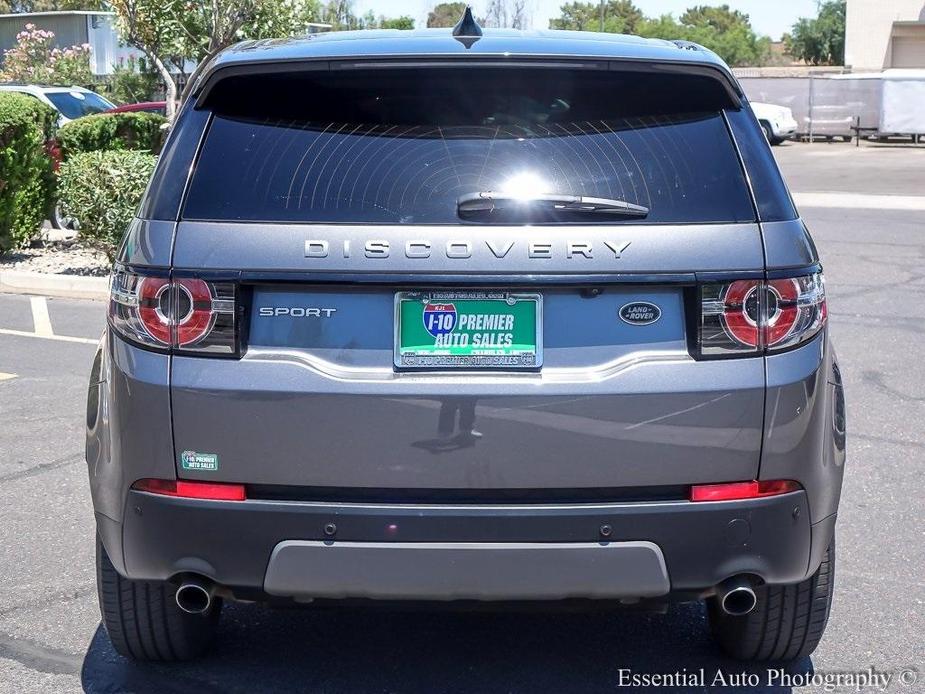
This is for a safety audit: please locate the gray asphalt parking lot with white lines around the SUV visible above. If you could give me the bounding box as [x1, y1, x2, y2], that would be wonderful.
[0, 144, 925, 694]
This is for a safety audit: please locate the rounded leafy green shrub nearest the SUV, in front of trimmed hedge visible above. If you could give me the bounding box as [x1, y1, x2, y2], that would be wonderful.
[58, 150, 157, 260]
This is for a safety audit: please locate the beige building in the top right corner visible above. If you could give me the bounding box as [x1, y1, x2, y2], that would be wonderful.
[845, 0, 925, 71]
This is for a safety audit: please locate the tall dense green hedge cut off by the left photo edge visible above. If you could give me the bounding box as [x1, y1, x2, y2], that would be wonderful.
[0, 93, 58, 254]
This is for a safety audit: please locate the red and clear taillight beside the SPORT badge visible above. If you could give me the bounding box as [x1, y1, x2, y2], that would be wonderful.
[109, 267, 237, 354]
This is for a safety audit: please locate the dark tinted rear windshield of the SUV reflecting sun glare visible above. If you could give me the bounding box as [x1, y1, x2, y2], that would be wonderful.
[184, 67, 754, 224]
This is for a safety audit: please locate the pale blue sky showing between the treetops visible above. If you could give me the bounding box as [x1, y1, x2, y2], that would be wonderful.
[355, 0, 816, 40]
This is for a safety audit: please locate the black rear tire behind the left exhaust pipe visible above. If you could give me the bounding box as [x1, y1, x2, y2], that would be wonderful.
[96, 537, 221, 661]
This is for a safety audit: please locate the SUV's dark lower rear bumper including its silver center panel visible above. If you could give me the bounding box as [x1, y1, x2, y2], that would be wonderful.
[122, 491, 829, 600]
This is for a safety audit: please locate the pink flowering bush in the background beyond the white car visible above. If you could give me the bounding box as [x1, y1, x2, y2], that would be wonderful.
[0, 24, 93, 86]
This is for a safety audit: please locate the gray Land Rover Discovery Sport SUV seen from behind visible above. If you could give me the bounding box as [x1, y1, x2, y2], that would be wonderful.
[87, 17, 845, 660]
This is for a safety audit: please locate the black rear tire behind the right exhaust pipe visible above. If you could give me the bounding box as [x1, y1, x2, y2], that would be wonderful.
[707, 540, 835, 661]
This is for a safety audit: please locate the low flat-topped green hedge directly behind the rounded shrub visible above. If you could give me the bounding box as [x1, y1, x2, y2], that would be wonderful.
[58, 111, 167, 159]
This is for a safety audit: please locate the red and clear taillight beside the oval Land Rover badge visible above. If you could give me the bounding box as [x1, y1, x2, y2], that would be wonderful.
[698, 272, 826, 357]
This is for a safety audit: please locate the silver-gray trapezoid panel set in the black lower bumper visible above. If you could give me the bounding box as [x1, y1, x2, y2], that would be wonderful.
[264, 540, 669, 600]
